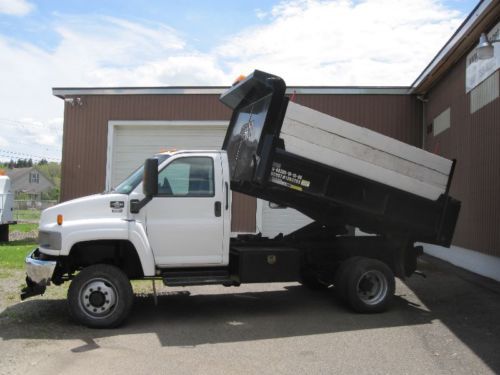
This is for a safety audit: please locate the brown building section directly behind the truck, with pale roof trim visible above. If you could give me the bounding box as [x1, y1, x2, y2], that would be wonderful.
[54, 87, 421, 232]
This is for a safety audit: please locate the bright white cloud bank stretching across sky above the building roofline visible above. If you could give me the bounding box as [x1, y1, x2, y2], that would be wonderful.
[0, 0, 462, 162]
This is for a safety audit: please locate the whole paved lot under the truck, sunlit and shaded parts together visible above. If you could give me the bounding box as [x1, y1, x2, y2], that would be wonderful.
[0, 257, 500, 375]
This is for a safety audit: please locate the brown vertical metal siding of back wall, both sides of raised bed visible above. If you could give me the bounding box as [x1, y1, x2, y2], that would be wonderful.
[61, 94, 421, 236]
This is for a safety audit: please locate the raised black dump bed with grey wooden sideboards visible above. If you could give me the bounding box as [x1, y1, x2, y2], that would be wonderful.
[221, 71, 460, 246]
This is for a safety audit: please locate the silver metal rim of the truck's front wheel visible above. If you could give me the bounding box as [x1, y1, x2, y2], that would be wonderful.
[79, 279, 118, 319]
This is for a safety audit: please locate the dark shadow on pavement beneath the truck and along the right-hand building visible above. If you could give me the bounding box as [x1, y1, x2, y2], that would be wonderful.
[0, 257, 500, 372]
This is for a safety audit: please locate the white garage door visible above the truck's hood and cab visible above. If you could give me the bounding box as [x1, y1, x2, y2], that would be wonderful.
[106, 121, 227, 188]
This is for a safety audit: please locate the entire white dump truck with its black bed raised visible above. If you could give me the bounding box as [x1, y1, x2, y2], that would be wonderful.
[22, 71, 460, 327]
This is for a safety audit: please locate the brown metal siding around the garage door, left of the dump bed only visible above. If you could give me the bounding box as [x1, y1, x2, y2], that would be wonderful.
[61, 95, 230, 201]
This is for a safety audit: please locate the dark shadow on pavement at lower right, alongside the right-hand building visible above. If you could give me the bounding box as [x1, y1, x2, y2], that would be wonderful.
[405, 255, 500, 374]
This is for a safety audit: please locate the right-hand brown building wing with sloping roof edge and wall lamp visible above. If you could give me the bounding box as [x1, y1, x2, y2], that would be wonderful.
[412, 1, 500, 279]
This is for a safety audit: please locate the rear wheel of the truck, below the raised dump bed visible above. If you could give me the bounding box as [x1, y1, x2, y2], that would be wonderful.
[346, 258, 395, 313]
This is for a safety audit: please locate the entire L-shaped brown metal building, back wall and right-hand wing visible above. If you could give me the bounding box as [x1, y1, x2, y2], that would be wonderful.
[53, 0, 500, 280]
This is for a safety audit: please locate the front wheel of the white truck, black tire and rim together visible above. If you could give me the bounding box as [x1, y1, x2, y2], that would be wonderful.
[68, 264, 134, 328]
